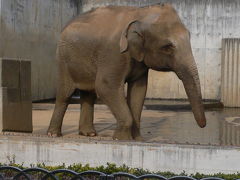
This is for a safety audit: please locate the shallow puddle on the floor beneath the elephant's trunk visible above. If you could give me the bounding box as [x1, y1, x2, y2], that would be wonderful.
[142, 108, 240, 146]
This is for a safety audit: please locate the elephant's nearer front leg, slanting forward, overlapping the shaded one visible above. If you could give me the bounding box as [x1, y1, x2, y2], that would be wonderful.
[96, 80, 133, 140]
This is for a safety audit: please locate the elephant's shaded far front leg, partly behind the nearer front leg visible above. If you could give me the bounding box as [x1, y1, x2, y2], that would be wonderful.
[127, 73, 148, 141]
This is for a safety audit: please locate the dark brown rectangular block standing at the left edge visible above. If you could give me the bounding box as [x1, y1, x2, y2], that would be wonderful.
[0, 59, 33, 132]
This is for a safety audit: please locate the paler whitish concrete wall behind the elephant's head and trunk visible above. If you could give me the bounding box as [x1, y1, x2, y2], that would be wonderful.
[81, 0, 240, 100]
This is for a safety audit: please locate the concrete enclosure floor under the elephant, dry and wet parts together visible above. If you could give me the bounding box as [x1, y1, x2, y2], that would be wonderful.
[30, 101, 240, 146]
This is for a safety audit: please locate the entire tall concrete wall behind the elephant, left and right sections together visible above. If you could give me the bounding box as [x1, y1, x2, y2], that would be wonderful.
[0, 0, 240, 100]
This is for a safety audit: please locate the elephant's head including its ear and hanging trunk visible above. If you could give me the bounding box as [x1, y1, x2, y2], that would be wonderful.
[120, 5, 206, 128]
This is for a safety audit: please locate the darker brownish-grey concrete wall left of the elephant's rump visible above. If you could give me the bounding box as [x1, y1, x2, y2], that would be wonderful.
[0, 0, 79, 100]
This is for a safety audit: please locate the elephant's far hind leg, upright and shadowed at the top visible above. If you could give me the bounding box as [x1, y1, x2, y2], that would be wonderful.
[79, 91, 96, 136]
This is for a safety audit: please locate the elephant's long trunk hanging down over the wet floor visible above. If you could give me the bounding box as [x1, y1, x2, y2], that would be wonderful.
[176, 60, 206, 128]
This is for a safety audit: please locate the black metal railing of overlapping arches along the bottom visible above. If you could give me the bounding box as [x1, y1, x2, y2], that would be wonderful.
[0, 166, 236, 180]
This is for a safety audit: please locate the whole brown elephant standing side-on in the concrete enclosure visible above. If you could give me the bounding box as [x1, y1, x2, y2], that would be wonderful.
[47, 4, 206, 140]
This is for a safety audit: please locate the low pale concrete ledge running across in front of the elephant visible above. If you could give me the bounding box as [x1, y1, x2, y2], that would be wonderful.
[0, 134, 240, 174]
